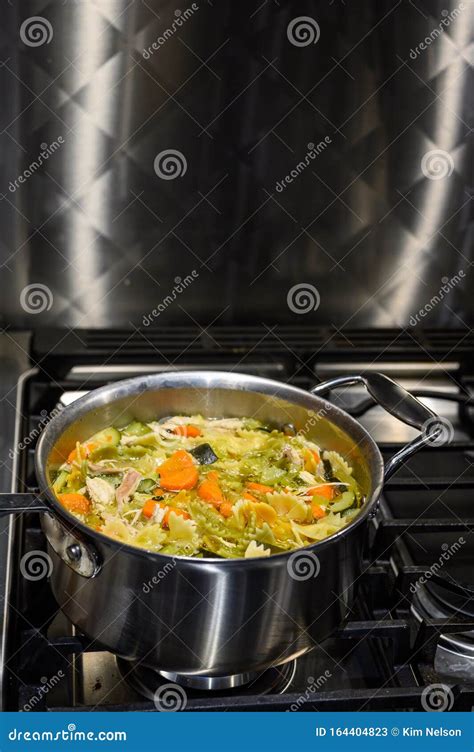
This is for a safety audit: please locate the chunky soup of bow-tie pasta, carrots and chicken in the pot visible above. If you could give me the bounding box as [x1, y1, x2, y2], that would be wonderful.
[53, 415, 363, 558]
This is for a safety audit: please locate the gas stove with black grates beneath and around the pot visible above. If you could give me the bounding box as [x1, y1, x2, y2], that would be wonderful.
[0, 327, 474, 711]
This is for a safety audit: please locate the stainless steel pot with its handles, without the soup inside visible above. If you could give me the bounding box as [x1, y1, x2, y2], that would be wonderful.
[0, 371, 436, 687]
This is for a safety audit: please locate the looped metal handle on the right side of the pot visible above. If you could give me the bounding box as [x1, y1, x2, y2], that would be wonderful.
[310, 372, 443, 480]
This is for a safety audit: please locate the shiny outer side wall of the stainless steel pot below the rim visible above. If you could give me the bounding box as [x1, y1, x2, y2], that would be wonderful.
[44, 506, 365, 677]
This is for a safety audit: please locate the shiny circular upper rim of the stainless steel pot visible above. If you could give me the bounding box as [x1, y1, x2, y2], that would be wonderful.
[35, 370, 384, 567]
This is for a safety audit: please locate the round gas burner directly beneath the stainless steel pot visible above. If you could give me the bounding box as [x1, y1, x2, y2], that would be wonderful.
[116, 658, 296, 700]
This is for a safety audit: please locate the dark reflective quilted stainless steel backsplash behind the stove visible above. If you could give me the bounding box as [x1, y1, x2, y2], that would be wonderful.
[0, 0, 474, 329]
